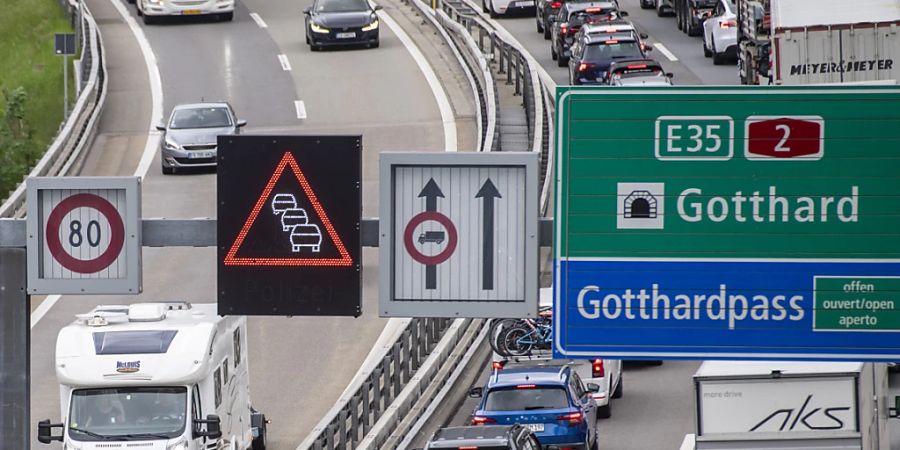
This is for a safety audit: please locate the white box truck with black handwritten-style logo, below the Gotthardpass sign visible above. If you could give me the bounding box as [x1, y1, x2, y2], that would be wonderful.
[694, 361, 893, 450]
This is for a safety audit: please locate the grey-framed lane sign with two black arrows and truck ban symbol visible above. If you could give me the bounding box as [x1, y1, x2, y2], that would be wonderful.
[379, 153, 538, 317]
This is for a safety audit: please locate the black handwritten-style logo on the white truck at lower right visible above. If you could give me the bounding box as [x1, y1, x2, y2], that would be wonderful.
[750, 394, 852, 432]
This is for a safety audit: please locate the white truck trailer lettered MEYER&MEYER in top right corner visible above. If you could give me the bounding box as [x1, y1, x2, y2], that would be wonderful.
[770, 0, 900, 85]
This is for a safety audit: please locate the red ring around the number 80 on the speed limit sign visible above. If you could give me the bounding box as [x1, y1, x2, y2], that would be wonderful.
[45, 193, 125, 273]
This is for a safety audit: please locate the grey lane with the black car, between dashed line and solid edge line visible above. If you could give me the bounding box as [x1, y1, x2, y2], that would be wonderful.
[236, 0, 444, 442]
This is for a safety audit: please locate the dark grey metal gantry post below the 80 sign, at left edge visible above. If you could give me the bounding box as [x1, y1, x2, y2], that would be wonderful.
[0, 248, 31, 449]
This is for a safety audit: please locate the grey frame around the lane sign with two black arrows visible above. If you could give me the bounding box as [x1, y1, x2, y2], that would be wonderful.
[378, 152, 539, 318]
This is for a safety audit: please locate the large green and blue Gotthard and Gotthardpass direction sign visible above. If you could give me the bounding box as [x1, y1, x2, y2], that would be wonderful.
[554, 87, 900, 361]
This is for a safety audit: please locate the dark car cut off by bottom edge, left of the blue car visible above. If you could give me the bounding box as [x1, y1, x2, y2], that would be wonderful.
[425, 425, 541, 450]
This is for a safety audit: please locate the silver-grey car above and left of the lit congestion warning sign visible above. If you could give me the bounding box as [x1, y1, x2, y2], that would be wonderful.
[156, 102, 247, 175]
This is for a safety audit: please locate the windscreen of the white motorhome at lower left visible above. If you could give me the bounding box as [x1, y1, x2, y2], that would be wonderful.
[67, 386, 188, 441]
